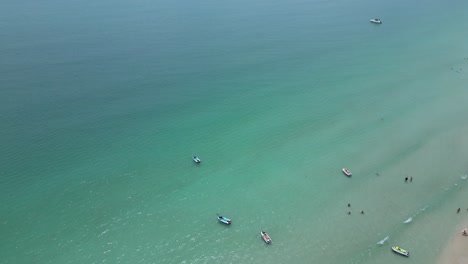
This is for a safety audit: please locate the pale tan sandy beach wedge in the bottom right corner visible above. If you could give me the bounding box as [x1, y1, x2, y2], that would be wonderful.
[437, 217, 468, 264]
